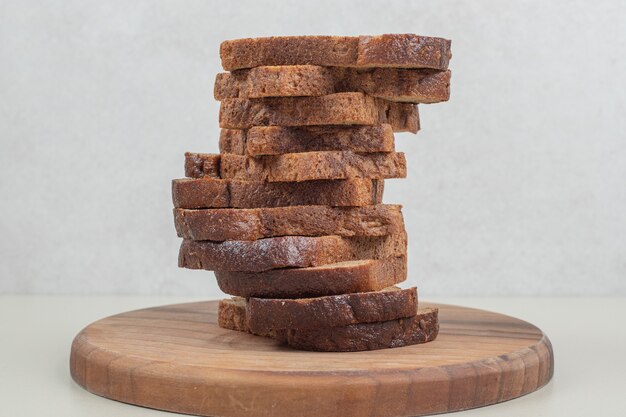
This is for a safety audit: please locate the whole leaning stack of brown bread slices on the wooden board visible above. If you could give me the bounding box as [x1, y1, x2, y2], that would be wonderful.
[172, 35, 451, 351]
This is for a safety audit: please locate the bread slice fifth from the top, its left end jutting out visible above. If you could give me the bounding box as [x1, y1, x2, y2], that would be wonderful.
[185, 151, 406, 182]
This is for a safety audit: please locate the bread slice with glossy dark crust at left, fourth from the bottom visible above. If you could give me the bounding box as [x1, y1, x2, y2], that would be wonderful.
[178, 233, 407, 272]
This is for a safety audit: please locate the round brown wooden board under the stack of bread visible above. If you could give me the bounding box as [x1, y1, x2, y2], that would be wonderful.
[70, 301, 554, 417]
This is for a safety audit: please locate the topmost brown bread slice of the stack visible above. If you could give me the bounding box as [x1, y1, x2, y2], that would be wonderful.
[220, 34, 452, 71]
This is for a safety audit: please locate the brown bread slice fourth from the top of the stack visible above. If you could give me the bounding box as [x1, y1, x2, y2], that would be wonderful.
[220, 124, 395, 156]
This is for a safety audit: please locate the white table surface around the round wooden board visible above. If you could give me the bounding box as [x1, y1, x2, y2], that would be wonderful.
[0, 295, 626, 417]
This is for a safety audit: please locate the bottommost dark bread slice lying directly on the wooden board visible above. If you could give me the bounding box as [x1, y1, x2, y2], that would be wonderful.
[218, 297, 439, 352]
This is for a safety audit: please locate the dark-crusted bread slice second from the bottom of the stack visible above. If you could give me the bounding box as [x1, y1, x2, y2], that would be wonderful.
[246, 287, 417, 334]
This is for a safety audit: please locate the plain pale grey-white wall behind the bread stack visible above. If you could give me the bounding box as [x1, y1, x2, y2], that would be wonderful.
[0, 0, 626, 298]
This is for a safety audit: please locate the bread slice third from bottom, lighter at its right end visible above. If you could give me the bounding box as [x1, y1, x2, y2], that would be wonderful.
[215, 256, 407, 298]
